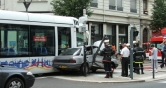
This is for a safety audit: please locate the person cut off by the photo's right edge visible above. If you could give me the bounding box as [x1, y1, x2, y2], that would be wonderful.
[160, 40, 166, 68]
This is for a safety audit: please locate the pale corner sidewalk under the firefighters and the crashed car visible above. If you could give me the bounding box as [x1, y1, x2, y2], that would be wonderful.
[53, 67, 166, 83]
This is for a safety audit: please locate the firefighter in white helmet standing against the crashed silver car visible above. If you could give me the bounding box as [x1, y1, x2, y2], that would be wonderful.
[101, 40, 114, 78]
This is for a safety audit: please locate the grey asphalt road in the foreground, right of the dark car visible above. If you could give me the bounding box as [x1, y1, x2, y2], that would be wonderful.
[32, 77, 166, 88]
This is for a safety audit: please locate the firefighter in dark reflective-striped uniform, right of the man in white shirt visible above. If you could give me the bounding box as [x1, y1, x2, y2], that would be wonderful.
[133, 43, 146, 74]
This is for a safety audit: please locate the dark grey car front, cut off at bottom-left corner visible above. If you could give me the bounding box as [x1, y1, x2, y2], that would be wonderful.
[0, 65, 35, 88]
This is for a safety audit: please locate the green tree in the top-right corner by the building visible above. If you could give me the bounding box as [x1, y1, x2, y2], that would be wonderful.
[150, 0, 166, 31]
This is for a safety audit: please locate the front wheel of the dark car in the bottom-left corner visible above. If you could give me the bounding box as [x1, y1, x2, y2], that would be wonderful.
[5, 78, 25, 88]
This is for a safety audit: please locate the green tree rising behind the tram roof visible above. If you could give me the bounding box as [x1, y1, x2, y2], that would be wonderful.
[50, 0, 93, 18]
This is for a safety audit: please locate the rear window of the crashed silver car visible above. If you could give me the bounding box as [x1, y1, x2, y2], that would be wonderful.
[60, 48, 81, 55]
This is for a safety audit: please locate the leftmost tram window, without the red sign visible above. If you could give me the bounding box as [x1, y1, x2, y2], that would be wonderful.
[0, 24, 29, 57]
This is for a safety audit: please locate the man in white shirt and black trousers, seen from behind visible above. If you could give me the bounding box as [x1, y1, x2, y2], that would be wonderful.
[120, 43, 130, 77]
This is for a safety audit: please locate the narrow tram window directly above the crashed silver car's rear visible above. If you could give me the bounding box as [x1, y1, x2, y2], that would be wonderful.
[58, 27, 71, 55]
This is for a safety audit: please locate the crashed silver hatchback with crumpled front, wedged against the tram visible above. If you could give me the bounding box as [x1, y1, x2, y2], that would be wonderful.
[53, 46, 118, 73]
